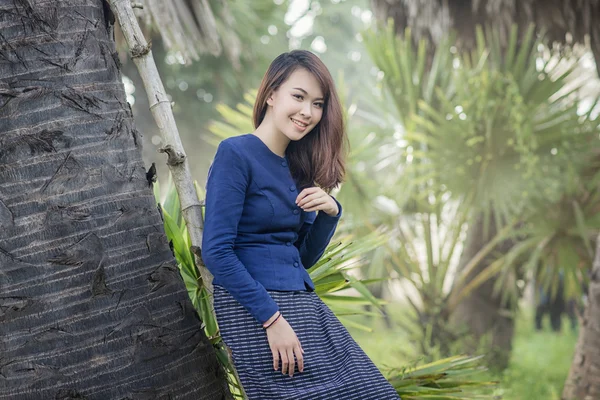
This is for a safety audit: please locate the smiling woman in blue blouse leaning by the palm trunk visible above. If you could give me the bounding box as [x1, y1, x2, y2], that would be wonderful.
[202, 50, 399, 400]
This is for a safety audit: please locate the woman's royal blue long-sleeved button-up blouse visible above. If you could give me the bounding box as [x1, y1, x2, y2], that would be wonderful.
[202, 134, 342, 324]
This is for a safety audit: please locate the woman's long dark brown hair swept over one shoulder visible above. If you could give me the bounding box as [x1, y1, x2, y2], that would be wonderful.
[253, 50, 348, 192]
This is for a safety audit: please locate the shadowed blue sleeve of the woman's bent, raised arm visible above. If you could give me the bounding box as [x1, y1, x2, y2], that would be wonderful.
[295, 196, 342, 269]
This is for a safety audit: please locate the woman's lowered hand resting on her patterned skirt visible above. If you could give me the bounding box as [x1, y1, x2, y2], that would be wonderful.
[267, 315, 304, 377]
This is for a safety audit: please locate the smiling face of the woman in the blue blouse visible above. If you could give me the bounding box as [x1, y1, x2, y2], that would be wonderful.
[267, 68, 324, 140]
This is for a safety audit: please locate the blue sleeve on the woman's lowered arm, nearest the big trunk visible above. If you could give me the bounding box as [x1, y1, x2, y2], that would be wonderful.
[202, 141, 279, 324]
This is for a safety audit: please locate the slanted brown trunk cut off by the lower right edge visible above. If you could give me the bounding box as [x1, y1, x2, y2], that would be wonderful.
[562, 236, 600, 400]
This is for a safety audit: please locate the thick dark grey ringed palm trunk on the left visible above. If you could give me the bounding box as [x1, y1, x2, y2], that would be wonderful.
[0, 0, 230, 400]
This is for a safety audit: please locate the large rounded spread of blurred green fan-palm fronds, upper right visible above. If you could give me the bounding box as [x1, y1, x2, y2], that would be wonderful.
[366, 21, 598, 222]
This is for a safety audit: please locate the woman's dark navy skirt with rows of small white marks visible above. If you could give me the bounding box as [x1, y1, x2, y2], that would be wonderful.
[214, 285, 400, 400]
